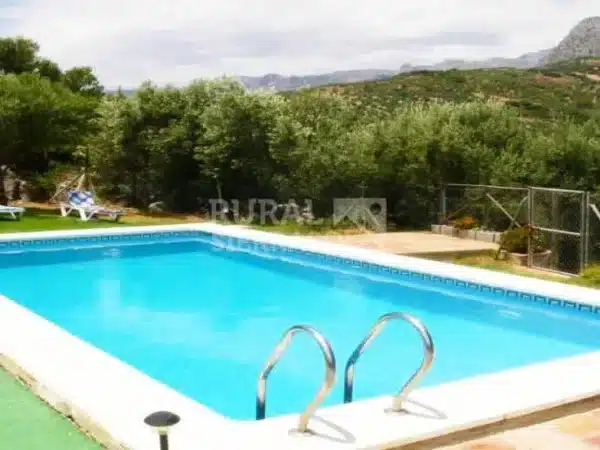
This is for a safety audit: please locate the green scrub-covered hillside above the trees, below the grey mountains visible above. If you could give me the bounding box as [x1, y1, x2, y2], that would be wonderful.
[304, 58, 600, 120]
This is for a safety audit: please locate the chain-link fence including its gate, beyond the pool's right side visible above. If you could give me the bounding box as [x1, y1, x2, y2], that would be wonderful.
[438, 184, 600, 274]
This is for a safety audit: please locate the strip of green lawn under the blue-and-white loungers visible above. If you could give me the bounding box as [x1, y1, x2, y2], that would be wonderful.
[0, 208, 195, 233]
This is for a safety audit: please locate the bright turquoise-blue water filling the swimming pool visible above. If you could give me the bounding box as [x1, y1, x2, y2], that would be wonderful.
[0, 235, 600, 419]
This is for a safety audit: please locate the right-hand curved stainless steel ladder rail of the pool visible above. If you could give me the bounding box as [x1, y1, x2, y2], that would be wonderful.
[344, 312, 435, 411]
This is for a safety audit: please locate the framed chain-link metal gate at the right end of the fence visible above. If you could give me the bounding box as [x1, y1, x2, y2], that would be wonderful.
[528, 187, 584, 274]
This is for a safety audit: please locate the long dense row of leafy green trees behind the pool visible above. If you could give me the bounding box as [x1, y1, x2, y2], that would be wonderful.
[77, 65, 600, 227]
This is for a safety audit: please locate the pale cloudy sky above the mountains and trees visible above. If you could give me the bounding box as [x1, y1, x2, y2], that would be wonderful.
[0, 0, 600, 87]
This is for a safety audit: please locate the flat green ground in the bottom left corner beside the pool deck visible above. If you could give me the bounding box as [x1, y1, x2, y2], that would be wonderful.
[0, 369, 103, 450]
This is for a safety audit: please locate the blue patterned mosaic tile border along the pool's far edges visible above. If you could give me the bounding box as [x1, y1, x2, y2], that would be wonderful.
[0, 230, 600, 316]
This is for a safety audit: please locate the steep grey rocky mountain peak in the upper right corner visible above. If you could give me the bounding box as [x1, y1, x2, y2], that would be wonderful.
[543, 17, 600, 64]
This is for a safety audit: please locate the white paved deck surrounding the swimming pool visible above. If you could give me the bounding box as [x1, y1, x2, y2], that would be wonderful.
[0, 223, 600, 450]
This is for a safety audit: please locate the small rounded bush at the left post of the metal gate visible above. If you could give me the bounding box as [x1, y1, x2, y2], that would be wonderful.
[500, 225, 552, 266]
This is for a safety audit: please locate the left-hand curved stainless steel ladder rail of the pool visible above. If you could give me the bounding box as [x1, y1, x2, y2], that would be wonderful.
[256, 325, 336, 433]
